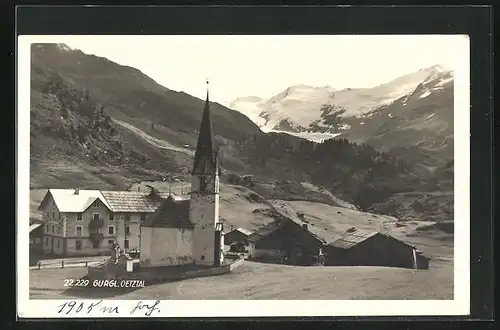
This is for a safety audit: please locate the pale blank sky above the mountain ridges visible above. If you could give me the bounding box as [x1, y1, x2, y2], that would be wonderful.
[42, 35, 468, 105]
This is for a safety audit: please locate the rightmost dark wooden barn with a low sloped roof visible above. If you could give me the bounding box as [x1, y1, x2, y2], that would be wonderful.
[324, 228, 430, 269]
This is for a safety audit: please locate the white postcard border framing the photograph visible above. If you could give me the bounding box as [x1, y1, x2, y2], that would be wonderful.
[16, 35, 470, 318]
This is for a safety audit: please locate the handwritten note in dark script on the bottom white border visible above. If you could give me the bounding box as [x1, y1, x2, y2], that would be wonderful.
[57, 299, 160, 316]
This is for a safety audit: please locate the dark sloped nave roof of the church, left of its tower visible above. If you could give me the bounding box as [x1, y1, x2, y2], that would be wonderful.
[143, 197, 194, 228]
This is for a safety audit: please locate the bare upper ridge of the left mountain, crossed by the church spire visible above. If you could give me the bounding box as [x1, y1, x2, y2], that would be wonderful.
[31, 44, 259, 144]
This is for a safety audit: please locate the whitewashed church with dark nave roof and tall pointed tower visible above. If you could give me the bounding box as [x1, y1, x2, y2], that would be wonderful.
[140, 85, 224, 268]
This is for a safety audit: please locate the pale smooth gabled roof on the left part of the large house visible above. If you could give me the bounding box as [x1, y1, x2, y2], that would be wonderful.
[38, 189, 110, 212]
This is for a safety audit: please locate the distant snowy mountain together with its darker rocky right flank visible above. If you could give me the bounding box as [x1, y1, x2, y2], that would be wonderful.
[231, 66, 453, 166]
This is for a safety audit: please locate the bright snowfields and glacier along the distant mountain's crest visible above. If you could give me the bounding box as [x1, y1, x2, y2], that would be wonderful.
[230, 66, 453, 133]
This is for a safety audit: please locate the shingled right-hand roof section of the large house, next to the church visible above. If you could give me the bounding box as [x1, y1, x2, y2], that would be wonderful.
[102, 191, 161, 213]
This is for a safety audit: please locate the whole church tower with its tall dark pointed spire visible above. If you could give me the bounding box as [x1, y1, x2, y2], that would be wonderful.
[189, 82, 223, 265]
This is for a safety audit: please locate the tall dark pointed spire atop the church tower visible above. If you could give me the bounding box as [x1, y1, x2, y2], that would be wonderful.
[192, 80, 217, 174]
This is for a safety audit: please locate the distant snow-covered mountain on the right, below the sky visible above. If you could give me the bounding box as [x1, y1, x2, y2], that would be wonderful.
[230, 65, 453, 141]
